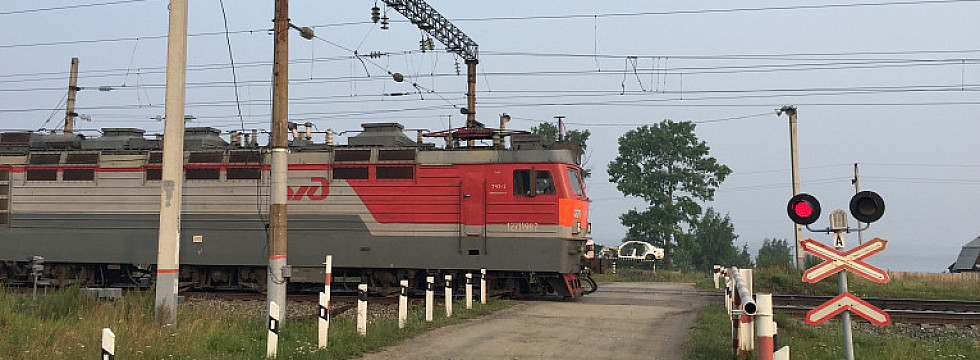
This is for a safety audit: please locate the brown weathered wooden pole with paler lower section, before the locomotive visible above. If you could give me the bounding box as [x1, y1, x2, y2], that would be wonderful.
[266, 0, 289, 321]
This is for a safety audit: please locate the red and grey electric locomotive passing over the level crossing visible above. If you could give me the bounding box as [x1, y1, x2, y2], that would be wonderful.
[0, 123, 590, 297]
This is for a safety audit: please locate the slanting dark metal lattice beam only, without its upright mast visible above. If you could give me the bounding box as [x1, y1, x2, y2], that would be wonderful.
[383, 0, 479, 63]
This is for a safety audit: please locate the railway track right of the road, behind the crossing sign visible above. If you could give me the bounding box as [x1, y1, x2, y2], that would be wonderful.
[772, 294, 980, 325]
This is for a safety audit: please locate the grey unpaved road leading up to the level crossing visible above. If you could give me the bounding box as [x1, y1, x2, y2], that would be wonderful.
[361, 283, 721, 360]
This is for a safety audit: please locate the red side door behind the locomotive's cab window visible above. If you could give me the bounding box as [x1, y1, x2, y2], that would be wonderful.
[459, 166, 487, 256]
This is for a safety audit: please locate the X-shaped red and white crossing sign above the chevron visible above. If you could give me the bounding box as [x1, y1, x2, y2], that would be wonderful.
[800, 238, 890, 283]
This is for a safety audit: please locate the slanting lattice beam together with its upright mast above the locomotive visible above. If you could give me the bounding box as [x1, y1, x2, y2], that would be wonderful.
[382, 0, 483, 128]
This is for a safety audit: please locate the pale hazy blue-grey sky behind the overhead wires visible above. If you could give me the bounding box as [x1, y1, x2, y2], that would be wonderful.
[0, 0, 980, 272]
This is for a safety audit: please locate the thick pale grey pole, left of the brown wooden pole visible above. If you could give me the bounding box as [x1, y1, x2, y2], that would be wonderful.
[154, 0, 187, 325]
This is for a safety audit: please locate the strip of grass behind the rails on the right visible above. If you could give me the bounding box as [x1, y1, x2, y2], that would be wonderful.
[752, 269, 980, 300]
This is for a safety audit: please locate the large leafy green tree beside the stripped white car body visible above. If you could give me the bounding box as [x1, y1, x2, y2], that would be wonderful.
[607, 120, 732, 260]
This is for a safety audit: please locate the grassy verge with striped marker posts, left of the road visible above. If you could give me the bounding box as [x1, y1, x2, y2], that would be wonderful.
[0, 287, 515, 360]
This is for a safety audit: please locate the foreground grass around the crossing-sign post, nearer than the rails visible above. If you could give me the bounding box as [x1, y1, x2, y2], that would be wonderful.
[684, 305, 980, 360]
